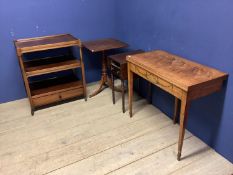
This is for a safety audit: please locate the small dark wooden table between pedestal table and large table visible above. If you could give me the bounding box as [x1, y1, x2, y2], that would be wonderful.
[108, 50, 144, 113]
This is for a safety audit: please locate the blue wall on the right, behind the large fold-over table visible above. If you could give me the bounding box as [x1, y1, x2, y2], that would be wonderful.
[117, 0, 233, 162]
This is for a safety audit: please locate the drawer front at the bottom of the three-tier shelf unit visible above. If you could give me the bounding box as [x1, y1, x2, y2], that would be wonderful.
[32, 88, 83, 107]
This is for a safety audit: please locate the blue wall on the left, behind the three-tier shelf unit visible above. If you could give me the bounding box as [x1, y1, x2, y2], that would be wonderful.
[0, 0, 115, 103]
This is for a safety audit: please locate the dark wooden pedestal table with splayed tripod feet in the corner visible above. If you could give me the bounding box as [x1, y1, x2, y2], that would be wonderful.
[83, 38, 128, 98]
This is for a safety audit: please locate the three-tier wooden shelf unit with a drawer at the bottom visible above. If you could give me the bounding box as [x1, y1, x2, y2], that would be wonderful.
[15, 34, 87, 115]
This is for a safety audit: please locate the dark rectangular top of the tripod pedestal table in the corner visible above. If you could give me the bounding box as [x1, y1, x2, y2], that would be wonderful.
[82, 38, 128, 52]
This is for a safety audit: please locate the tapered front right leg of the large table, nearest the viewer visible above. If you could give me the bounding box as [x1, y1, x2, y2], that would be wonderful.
[177, 99, 190, 161]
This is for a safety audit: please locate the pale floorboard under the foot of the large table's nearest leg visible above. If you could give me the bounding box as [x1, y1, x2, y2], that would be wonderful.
[109, 137, 213, 175]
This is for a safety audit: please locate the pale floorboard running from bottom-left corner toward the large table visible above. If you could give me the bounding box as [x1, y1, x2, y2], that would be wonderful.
[2, 116, 171, 175]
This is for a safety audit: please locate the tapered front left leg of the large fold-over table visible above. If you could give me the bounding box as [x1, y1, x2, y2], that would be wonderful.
[128, 63, 133, 117]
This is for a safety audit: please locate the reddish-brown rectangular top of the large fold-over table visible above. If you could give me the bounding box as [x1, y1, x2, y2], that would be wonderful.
[127, 50, 228, 90]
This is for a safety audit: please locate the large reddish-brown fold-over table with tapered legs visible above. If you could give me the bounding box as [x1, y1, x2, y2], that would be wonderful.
[127, 51, 228, 160]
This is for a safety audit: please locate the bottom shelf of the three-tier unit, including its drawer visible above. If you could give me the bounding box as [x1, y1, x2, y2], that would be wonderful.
[30, 76, 84, 107]
